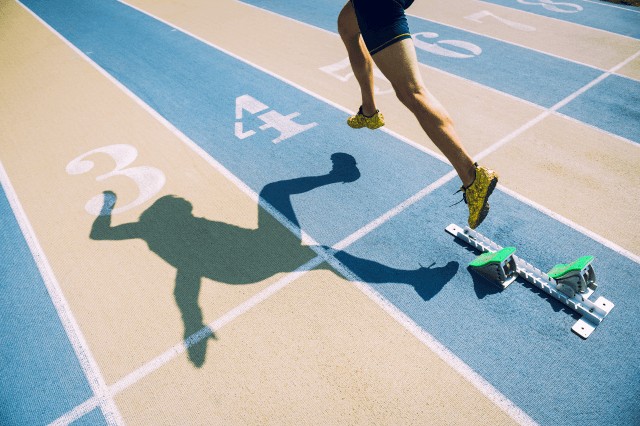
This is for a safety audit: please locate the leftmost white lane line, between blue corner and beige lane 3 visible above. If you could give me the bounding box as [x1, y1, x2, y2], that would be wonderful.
[0, 161, 124, 425]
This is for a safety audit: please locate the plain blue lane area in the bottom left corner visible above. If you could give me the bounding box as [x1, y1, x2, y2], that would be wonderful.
[0, 187, 105, 426]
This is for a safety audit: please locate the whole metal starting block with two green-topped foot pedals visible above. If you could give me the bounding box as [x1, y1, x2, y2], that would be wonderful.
[446, 223, 614, 339]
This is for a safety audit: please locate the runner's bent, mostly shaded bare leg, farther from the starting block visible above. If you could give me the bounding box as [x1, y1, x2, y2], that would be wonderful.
[338, 2, 376, 116]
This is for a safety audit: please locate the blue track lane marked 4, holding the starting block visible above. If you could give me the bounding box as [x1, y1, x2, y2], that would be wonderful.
[17, 0, 640, 425]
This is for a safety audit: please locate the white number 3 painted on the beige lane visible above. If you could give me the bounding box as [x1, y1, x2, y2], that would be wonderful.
[66, 144, 166, 216]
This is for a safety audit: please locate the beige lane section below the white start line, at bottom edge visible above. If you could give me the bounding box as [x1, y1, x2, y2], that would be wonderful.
[116, 270, 513, 425]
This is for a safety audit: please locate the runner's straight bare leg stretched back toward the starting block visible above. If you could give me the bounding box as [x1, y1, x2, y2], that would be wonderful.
[373, 39, 475, 187]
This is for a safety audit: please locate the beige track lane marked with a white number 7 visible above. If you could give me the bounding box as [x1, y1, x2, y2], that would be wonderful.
[407, 0, 639, 74]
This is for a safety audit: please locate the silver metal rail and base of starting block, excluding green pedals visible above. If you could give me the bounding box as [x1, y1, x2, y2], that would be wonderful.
[445, 223, 615, 339]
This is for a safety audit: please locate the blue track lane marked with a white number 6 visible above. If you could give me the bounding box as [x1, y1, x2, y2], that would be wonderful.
[243, 0, 640, 142]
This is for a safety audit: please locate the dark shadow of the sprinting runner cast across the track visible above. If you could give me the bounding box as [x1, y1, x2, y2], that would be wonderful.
[90, 153, 458, 368]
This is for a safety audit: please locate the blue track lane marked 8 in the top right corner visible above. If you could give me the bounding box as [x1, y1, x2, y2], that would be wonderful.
[481, 0, 640, 38]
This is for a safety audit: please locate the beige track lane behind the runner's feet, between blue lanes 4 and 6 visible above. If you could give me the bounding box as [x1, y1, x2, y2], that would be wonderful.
[122, 0, 640, 254]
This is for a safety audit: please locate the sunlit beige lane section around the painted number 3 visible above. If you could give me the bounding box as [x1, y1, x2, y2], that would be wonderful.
[0, 2, 314, 384]
